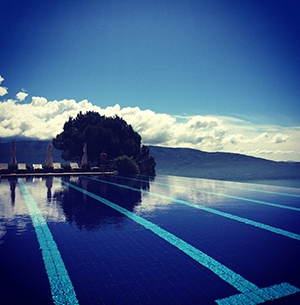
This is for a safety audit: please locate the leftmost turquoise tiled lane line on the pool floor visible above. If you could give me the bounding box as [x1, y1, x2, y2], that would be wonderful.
[18, 178, 79, 305]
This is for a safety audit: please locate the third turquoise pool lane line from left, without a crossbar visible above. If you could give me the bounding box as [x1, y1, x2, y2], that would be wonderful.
[84, 176, 300, 241]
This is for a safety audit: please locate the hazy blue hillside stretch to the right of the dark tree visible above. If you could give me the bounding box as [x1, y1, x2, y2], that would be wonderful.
[149, 146, 300, 181]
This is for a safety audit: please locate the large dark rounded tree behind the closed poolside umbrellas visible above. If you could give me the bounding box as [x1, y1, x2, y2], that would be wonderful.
[52, 111, 155, 174]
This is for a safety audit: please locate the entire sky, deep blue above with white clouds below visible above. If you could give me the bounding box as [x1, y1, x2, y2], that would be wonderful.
[0, 0, 300, 161]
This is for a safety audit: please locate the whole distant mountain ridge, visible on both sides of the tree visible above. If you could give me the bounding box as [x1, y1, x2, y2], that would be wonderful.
[0, 139, 300, 181]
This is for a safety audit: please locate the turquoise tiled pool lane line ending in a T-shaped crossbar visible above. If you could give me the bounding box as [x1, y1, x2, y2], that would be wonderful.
[54, 178, 300, 305]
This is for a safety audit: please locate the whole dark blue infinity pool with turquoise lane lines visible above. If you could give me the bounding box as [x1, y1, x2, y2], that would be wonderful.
[0, 175, 300, 304]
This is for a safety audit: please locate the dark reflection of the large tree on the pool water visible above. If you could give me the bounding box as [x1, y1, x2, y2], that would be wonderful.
[53, 175, 149, 230]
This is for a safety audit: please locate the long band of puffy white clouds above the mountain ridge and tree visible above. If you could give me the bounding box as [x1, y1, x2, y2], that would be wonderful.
[0, 77, 300, 161]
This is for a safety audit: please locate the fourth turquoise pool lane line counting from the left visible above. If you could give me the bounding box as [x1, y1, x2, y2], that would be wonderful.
[117, 176, 300, 212]
